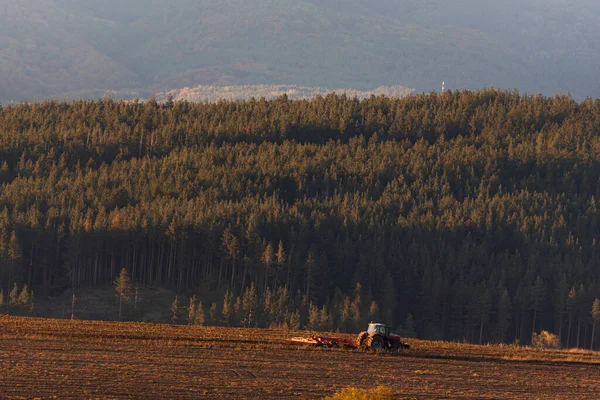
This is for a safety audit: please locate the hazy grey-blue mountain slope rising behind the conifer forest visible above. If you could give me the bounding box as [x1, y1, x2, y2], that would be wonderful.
[0, 0, 600, 101]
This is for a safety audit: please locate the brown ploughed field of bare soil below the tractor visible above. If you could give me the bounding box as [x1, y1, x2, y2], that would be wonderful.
[0, 317, 600, 399]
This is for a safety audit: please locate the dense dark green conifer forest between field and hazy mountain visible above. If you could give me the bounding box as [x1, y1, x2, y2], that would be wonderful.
[0, 90, 600, 347]
